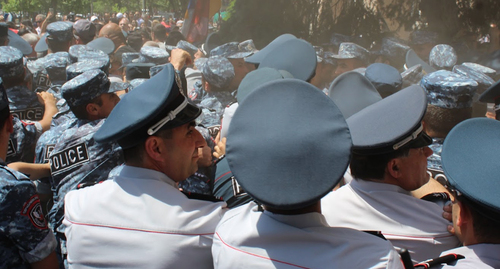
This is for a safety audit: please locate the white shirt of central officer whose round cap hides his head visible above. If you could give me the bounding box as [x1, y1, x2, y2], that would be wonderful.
[212, 202, 403, 269]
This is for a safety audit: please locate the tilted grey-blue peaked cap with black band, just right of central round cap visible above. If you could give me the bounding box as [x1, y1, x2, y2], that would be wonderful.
[347, 85, 432, 155]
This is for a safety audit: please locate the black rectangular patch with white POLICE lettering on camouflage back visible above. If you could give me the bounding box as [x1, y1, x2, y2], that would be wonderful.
[50, 143, 89, 175]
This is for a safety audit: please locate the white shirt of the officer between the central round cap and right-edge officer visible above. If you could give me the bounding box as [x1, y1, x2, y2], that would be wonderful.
[321, 179, 460, 263]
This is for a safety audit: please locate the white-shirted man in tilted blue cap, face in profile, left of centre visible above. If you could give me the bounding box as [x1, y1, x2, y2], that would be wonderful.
[64, 64, 224, 268]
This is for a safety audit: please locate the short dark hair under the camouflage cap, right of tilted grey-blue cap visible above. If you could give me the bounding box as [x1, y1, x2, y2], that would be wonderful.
[424, 105, 472, 138]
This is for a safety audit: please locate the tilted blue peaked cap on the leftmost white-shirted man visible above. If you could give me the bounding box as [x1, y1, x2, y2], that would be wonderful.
[94, 64, 201, 149]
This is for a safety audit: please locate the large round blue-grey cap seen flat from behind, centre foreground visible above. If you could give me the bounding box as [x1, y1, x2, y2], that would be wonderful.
[226, 79, 351, 210]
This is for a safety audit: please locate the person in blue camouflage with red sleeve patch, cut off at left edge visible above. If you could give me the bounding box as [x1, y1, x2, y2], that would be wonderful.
[0, 79, 58, 268]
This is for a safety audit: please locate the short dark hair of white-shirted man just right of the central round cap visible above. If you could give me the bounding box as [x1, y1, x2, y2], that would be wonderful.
[350, 147, 410, 180]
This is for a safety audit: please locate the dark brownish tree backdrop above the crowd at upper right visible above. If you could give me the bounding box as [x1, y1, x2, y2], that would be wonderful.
[220, 0, 500, 47]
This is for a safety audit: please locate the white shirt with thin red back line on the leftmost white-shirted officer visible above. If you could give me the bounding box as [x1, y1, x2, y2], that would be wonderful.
[63, 166, 225, 268]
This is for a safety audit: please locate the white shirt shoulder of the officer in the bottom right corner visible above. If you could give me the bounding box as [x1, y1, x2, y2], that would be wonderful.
[432, 244, 500, 269]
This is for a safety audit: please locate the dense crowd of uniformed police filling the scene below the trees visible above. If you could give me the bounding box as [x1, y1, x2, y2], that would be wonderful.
[0, 8, 500, 268]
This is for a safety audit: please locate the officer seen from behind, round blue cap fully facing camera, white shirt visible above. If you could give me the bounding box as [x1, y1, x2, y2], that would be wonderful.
[212, 79, 402, 268]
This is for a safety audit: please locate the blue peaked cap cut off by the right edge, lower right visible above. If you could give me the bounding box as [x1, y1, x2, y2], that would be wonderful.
[441, 118, 500, 222]
